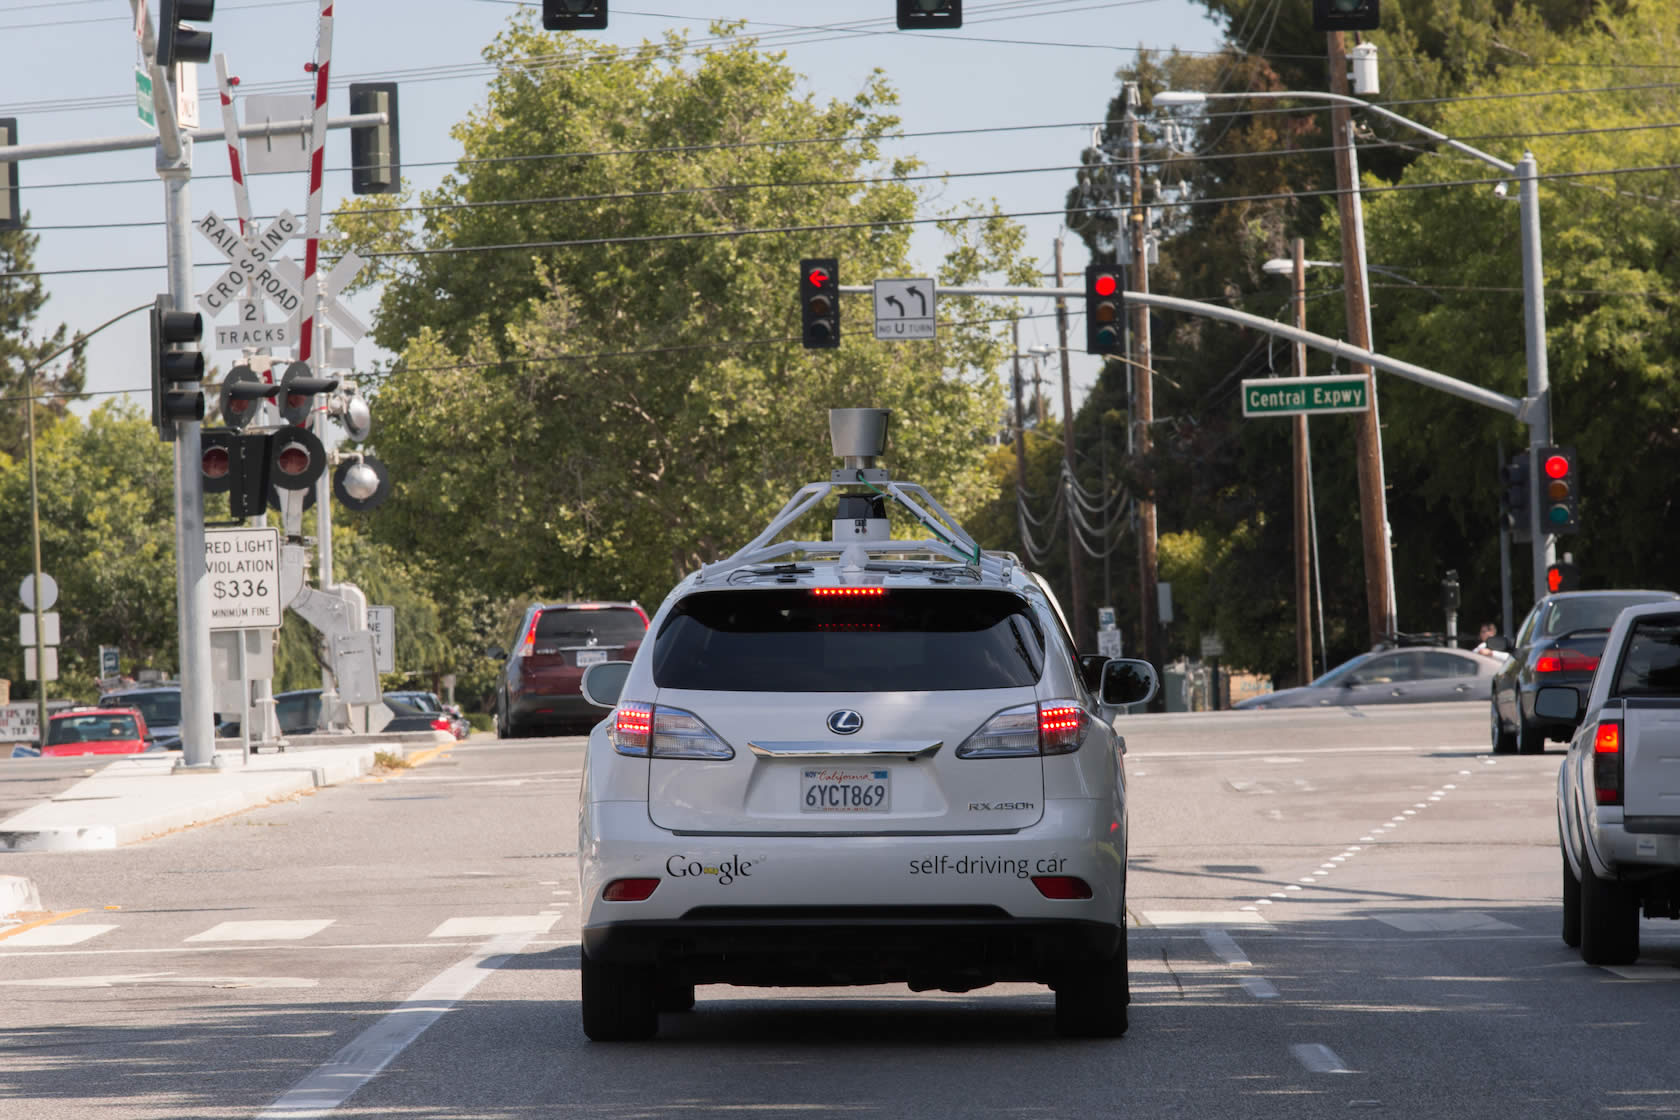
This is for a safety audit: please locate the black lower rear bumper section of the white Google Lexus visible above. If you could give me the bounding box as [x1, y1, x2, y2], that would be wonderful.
[583, 905, 1126, 991]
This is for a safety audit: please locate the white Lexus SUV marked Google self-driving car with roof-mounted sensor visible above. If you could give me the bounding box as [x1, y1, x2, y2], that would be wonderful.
[578, 408, 1156, 1041]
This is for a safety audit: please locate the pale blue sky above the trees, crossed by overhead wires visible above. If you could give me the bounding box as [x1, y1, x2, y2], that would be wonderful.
[0, 0, 1218, 419]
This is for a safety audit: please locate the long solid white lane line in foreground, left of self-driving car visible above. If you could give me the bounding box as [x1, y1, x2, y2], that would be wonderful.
[257, 932, 534, 1120]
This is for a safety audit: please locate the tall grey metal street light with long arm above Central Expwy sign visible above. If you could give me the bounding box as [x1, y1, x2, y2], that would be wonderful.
[1154, 89, 1557, 598]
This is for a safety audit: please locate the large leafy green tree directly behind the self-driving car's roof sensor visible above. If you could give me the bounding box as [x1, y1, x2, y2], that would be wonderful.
[338, 17, 1035, 604]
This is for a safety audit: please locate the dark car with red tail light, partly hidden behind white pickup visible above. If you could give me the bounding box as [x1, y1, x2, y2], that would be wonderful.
[1488, 591, 1680, 754]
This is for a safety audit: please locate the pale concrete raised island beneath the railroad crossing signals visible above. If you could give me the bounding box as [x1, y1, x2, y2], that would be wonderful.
[0, 732, 455, 925]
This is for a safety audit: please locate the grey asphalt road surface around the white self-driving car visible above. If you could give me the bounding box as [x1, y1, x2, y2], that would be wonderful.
[0, 704, 1680, 1120]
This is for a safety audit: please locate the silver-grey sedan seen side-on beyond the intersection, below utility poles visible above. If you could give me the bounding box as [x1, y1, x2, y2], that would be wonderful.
[1231, 646, 1499, 712]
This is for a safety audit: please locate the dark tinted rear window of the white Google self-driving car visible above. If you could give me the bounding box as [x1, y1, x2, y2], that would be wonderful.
[654, 588, 1045, 692]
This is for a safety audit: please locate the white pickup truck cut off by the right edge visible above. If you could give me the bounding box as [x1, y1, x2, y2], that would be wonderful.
[1536, 603, 1680, 964]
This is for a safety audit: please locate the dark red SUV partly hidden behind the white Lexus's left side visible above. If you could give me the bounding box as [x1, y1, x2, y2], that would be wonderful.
[491, 603, 647, 739]
